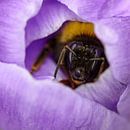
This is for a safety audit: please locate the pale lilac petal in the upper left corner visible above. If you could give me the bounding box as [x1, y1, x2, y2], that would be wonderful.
[0, 0, 42, 65]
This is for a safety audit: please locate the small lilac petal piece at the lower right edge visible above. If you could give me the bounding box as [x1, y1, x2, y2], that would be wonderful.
[117, 84, 130, 121]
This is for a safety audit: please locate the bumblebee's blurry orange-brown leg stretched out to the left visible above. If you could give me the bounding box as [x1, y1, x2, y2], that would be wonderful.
[30, 45, 50, 74]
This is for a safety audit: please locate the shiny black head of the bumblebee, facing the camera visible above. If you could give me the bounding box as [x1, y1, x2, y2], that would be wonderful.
[65, 41, 104, 84]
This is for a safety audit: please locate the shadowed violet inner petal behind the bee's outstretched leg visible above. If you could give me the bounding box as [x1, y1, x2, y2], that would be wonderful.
[25, 39, 65, 80]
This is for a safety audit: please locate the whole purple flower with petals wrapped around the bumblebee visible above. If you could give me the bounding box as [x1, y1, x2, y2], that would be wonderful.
[0, 0, 130, 130]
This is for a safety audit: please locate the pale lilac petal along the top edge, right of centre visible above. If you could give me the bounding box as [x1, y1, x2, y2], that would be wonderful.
[58, 0, 130, 21]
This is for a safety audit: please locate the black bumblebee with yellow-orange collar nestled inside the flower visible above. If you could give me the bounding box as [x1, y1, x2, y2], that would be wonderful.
[31, 21, 109, 89]
